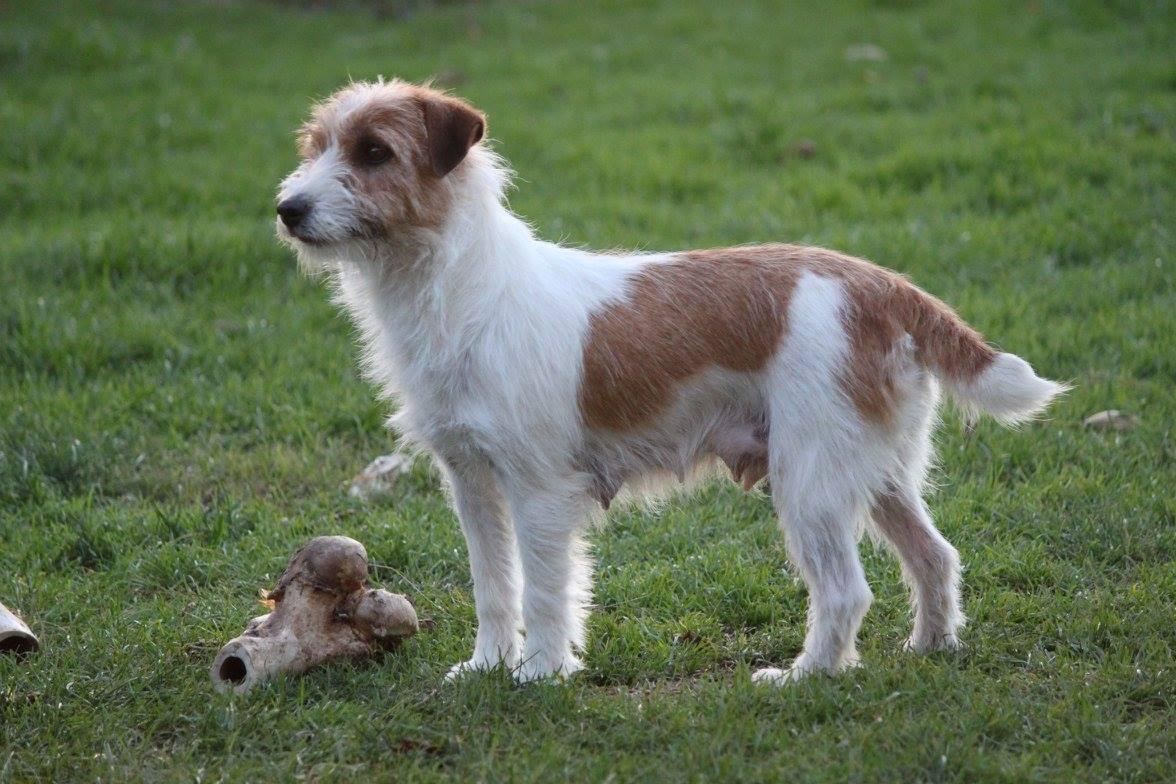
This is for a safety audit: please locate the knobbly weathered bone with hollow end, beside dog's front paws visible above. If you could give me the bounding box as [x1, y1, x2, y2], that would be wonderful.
[212, 536, 419, 692]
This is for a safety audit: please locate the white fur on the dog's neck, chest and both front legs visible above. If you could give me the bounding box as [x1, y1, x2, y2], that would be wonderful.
[292, 148, 643, 678]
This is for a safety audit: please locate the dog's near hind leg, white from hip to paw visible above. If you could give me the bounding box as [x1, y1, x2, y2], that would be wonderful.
[754, 271, 893, 684]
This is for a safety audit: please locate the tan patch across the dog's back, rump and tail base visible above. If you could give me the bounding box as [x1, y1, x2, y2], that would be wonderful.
[580, 244, 995, 430]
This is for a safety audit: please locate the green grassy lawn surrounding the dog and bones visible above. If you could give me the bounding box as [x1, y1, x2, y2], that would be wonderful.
[0, 0, 1176, 782]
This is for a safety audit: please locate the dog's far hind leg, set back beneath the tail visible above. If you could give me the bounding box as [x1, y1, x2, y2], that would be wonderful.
[870, 483, 964, 652]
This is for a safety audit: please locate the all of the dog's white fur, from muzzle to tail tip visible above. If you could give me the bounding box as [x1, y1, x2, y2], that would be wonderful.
[282, 93, 1058, 683]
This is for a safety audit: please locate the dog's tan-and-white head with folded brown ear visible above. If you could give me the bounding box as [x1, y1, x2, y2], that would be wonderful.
[278, 80, 486, 256]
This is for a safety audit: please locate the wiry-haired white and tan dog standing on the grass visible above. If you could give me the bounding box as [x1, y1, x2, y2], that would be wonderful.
[276, 80, 1067, 684]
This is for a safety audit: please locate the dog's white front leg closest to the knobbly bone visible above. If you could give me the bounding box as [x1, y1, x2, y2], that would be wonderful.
[441, 460, 522, 679]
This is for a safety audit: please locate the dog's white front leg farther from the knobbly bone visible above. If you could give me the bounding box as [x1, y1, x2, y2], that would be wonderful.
[508, 488, 592, 683]
